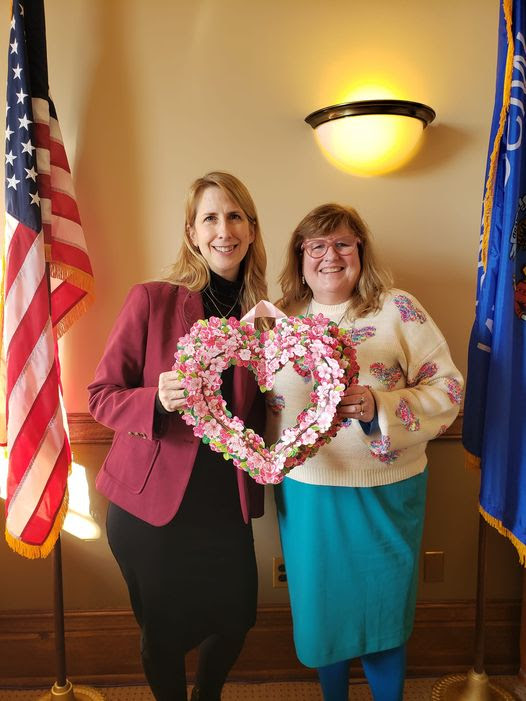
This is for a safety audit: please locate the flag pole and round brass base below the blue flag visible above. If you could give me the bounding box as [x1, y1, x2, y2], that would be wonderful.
[431, 514, 515, 701]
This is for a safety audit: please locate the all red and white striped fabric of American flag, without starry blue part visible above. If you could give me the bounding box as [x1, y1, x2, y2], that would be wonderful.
[2, 98, 93, 557]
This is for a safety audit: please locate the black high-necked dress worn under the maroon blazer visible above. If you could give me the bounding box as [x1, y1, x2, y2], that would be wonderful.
[107, 273, 262, 698]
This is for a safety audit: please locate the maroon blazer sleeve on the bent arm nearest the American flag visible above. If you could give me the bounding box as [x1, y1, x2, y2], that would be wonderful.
[88, 285, 161, 439]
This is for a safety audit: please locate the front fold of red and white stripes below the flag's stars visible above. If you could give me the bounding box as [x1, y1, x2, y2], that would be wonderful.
[3, 215, 69, 556]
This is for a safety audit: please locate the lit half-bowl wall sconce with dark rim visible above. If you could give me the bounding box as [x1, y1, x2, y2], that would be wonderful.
[305, 99, 436, 176]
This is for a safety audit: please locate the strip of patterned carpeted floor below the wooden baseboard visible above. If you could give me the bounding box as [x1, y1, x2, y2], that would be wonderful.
[0, 677, 526, 701]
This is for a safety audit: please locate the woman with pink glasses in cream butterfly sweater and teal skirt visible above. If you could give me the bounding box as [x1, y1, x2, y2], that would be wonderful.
[267, 204, 462, 701]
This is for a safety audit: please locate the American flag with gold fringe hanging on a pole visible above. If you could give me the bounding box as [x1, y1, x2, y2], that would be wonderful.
[0, 0, 93, 558]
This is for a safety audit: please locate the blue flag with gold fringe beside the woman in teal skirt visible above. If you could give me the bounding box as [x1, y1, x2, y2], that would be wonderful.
[463, 0, 526, 565]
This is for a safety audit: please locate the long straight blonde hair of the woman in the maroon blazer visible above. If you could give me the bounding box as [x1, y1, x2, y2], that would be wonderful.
[164, 171, 268, 314]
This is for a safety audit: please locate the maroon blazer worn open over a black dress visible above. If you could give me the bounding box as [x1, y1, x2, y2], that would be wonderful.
[88, 282, 264, 526]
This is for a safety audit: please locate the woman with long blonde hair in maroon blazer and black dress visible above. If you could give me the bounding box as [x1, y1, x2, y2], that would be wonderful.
[89, 171, 267, 701]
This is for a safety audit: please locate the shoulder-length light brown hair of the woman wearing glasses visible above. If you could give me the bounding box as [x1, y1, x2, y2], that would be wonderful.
[276, 204, 392, 316]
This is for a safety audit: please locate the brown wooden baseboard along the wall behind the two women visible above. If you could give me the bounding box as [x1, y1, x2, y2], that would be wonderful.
[0, 600, 520, 687]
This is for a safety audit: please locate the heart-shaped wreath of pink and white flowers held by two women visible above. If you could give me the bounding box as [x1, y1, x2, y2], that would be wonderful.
[173, 314, 359, 484]
